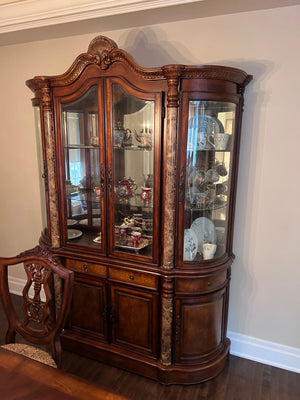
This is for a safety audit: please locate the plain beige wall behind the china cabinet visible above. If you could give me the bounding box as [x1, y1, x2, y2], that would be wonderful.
[0, 6, 300, 348]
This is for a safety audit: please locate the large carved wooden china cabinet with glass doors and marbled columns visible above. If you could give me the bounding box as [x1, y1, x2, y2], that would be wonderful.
[27, 36, 252, 384]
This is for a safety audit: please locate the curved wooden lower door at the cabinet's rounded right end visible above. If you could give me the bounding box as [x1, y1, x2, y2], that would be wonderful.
[174, 289, 226, 365]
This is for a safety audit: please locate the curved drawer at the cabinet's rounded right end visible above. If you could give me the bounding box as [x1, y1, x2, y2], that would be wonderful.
[175, 270, 227, 293]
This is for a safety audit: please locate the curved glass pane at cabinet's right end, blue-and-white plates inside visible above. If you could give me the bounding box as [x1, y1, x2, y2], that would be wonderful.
[179, 100, 236, 263]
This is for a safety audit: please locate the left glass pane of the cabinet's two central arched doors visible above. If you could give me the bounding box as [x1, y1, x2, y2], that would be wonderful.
[61, 86, 103, 249]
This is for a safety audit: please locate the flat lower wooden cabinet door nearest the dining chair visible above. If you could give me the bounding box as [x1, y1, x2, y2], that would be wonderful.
[69, 281, 108, 341]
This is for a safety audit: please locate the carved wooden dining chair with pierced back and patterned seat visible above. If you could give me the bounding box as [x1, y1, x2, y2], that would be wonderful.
[0, 246, 74, 368]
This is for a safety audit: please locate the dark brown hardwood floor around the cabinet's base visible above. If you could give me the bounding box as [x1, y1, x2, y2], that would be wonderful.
[0, 296, 300, 400]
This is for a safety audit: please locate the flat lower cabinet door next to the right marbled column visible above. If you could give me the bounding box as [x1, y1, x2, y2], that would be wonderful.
[110, 284, 159, 358]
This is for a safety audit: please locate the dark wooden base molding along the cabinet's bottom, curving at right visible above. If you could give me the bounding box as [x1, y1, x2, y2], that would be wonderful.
[62, 332, 230, 385]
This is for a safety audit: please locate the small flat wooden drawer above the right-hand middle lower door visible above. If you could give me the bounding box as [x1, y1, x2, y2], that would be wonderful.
[108, 268, 158, 289]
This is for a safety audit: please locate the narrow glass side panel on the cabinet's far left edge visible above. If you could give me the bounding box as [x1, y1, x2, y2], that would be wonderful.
[34, 106, 48, 238]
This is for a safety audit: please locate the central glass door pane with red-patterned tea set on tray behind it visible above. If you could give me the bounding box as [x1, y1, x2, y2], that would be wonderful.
[108, 80, 160, 258]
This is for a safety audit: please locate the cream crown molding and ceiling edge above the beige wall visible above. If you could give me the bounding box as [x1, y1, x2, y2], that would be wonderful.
[0, 0, 300, 45]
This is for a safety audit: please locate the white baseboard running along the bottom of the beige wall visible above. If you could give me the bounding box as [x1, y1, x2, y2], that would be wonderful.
[9, 278, 300, 373]
